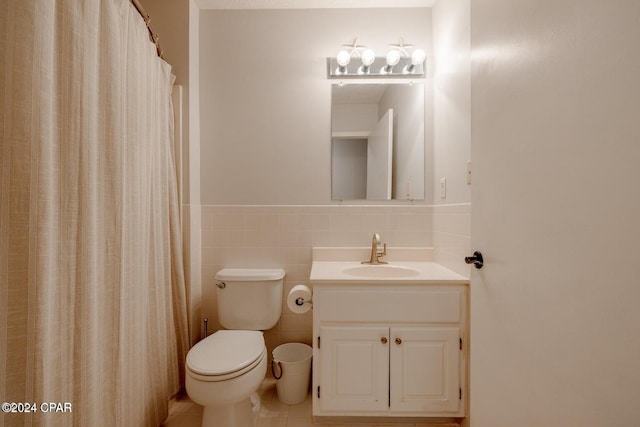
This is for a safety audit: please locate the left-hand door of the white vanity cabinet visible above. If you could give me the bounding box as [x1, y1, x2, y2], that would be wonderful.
[320, 326, 390, 414]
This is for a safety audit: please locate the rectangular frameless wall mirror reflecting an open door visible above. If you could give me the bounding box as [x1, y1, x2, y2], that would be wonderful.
[331, 83, 424, 200]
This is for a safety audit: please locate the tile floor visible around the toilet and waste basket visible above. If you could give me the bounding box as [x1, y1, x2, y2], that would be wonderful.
[162, 377, 458, 427]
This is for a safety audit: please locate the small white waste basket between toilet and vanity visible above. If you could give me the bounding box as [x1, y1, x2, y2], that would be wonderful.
[271, 342, 313, 405]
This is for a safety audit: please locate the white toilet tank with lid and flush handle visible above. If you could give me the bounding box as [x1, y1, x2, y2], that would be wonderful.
[216, 268, 284, 331]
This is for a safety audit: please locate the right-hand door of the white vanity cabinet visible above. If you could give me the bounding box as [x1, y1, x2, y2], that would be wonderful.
[390, 326, 461, 415]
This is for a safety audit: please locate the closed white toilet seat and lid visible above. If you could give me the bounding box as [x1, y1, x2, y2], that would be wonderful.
[186, 330, 266, 381]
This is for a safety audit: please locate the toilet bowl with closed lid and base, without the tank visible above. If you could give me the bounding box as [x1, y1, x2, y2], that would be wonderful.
[185, 330, 267, 427]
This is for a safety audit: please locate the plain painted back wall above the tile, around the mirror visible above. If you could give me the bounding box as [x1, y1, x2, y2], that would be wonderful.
[199, 8, 432, 205]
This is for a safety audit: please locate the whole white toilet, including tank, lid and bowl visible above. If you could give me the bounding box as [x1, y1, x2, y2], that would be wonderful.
[185, 268, 285, 427]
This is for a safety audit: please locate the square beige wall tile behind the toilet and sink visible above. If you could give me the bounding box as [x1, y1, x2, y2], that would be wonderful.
[201, 205, 469, 360]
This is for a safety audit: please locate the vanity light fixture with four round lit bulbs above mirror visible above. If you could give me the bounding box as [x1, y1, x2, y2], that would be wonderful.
[327, 39, 426, 79]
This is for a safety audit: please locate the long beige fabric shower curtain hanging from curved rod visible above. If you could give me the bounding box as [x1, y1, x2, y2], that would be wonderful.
[0, 0, 188, 426]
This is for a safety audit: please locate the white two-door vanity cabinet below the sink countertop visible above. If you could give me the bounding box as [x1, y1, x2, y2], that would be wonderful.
[313, 283, 467, 417]
